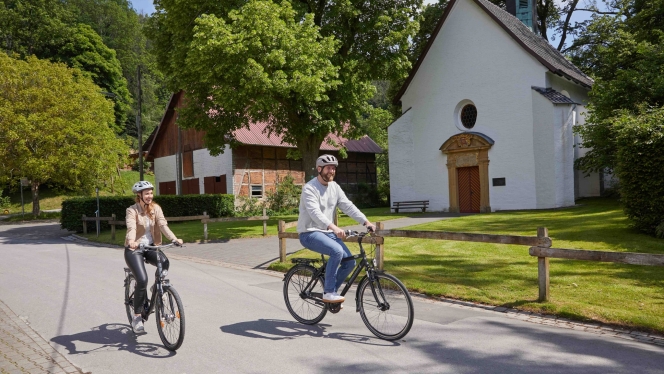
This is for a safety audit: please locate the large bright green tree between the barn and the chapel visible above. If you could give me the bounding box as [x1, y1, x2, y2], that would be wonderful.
[149, 0, 420, 179]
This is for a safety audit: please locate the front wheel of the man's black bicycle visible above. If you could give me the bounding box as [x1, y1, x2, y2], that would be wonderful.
[358, 273, 415, 340]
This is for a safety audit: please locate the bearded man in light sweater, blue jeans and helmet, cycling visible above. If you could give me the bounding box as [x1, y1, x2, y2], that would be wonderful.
[297, 155, 376, 303]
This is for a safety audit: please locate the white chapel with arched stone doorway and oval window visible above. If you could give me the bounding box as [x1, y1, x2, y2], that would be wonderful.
[388, 0, 603, 212]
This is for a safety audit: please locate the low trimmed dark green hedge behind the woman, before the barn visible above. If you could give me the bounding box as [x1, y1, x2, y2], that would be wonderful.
[60, 195, 235, 232]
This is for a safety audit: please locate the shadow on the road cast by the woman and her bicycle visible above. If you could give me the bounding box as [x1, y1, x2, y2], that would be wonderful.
[51, 323, 175, 358]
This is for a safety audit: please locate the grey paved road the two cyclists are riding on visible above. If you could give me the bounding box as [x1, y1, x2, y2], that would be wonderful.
[0, 225, 664, 374]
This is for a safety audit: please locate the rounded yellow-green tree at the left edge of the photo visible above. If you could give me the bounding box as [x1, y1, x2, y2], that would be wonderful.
[0, 52, 128, 215]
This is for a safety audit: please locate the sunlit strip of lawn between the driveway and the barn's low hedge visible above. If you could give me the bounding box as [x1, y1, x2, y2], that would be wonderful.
[78, 208, 421, 246]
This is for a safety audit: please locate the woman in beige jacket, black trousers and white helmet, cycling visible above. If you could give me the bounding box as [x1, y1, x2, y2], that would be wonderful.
[124, 181, 182, 332]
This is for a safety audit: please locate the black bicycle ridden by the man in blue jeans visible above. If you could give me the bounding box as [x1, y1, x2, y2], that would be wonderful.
[284, 230, 414, 340]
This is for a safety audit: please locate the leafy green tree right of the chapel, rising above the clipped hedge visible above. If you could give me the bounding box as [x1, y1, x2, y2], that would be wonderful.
[573, 0, 664, 172]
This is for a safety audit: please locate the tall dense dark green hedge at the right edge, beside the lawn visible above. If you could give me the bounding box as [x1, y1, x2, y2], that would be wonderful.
[616, 107, 664, 235]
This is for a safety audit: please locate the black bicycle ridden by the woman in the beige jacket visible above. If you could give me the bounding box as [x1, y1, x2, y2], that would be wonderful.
[124, 243, 184, 351]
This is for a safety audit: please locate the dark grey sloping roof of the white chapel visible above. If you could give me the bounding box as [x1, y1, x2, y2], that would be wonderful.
[394, 0, 593, 104]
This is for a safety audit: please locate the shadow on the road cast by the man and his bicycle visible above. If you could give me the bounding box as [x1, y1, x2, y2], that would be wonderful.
[220, 319, 400, 347]
